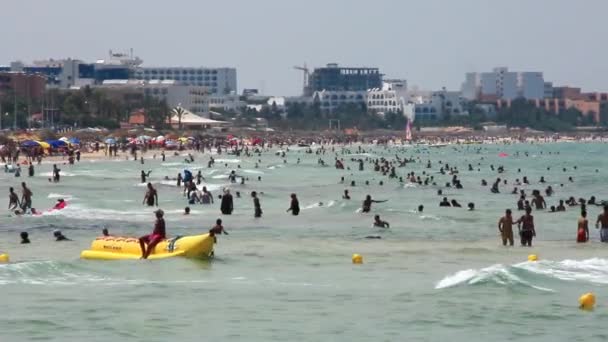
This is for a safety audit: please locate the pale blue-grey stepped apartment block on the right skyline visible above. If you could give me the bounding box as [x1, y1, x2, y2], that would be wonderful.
[461, 67, 546, 100]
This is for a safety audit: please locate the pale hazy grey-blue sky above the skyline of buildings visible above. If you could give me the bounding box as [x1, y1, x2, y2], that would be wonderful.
[0, 0, 608, 95]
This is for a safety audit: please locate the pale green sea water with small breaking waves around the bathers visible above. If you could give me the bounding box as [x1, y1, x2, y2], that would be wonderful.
[0, 143, 608, 341]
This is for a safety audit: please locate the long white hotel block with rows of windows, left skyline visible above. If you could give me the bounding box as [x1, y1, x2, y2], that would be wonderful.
[133, 67, 237, 95]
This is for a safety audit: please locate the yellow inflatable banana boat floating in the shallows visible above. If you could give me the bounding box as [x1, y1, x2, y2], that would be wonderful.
[80, 234, 214, 260]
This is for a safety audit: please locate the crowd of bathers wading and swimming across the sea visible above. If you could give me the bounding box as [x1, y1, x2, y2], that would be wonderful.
[5, 138, 608, 258]
